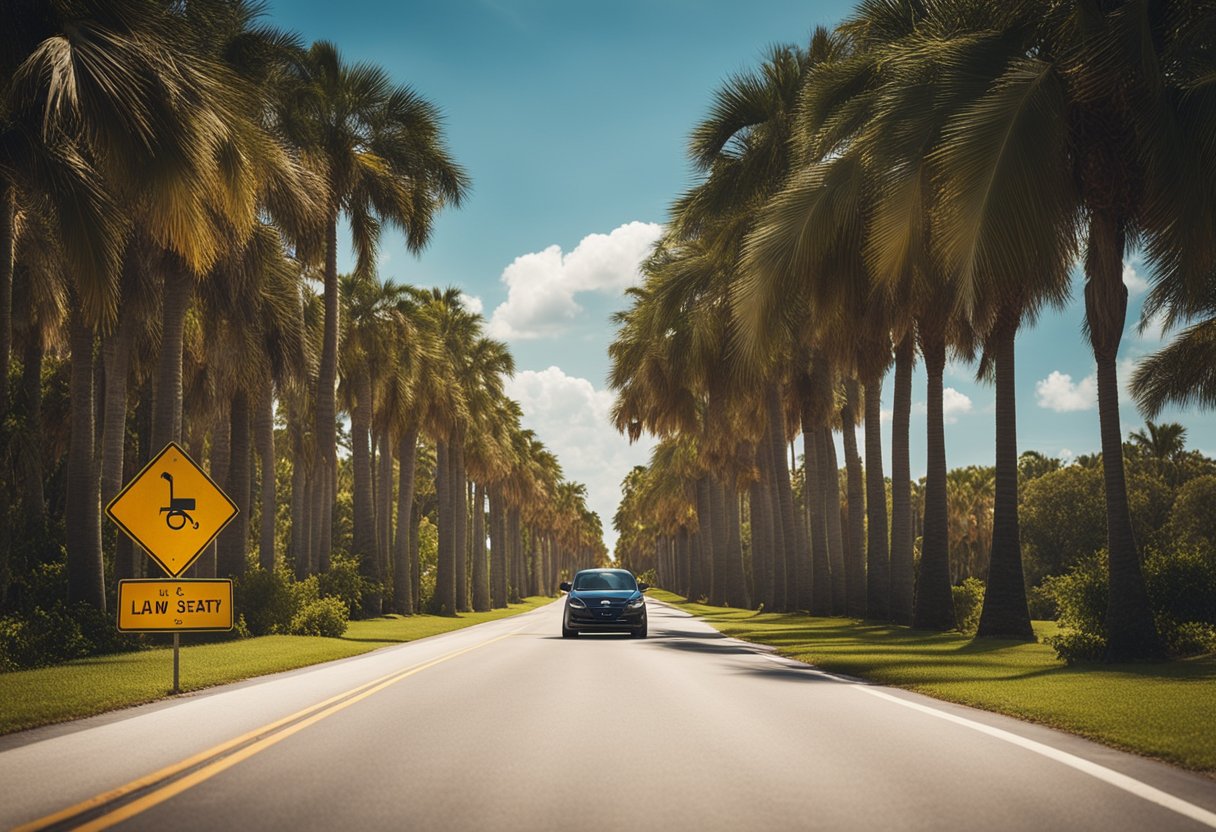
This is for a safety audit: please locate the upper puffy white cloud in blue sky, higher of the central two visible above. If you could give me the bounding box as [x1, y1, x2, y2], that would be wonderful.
[486, 221, 663, 341]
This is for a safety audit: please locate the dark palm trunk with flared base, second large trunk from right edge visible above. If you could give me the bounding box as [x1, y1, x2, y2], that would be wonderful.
[978, 310, 1035, 640]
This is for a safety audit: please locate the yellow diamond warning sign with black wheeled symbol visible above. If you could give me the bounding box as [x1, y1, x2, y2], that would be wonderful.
[106, 442, 237, 578]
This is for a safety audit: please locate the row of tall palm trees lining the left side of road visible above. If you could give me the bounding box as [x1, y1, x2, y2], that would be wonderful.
[0, 0, 603, 613]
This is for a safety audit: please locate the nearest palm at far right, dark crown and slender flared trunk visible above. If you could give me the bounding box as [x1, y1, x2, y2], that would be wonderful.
[914, 1, 1216, 660]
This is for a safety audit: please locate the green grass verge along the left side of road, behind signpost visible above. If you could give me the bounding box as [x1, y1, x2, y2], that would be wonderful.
[0, 597, 552, 733]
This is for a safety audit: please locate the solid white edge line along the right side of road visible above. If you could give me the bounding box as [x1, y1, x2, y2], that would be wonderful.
[758, 653, 1216, 828]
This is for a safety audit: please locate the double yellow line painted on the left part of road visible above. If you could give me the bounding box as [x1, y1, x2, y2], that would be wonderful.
[12, 631, 514, 832]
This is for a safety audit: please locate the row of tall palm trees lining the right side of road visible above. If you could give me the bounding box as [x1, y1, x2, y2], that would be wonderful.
[610, 0, 1216, 659]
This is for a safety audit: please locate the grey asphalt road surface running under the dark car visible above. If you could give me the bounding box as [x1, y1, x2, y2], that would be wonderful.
[0, 601, 1216, 832]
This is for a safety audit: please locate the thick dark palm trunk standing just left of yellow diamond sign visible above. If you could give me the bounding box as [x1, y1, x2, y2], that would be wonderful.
[64, 309, 106, 611]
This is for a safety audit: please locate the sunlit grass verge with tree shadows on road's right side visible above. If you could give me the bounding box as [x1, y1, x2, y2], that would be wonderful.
[648, 590, 1216, 774]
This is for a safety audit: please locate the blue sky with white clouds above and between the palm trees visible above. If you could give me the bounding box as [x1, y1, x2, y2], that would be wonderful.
[269, 0, 1216, 547]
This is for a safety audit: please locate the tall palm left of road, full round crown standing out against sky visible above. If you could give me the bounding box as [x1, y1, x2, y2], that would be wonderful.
[280, 40, 468, 569]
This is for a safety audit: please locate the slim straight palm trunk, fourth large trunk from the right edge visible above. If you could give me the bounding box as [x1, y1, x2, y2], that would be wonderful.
[890, 333, 916, 624]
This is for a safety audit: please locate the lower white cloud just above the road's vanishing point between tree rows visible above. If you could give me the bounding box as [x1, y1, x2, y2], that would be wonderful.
[506, 366, 653, 552]
